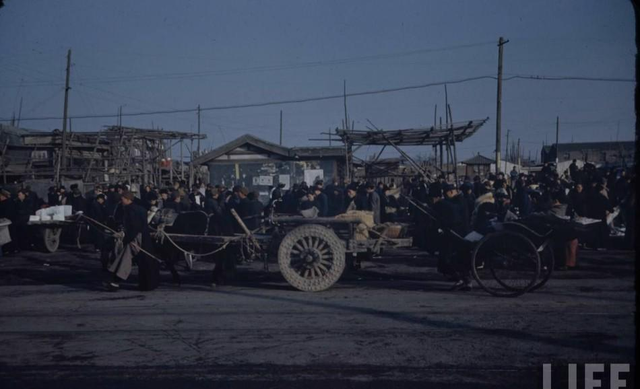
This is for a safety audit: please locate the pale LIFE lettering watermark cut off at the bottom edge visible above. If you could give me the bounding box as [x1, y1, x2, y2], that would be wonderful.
[542, 363, 631, 389]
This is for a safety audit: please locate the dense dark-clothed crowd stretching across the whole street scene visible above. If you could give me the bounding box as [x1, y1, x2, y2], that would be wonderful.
[0, 161, 635, 289]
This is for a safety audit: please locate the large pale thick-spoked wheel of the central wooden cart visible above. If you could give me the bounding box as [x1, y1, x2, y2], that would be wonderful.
[278, 224, 345, 292]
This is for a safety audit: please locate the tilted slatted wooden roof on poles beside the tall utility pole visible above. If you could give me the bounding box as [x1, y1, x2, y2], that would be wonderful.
[336, 118, 489, 146]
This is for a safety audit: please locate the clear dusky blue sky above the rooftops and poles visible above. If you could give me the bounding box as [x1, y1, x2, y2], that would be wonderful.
[0, 0, 636, 159]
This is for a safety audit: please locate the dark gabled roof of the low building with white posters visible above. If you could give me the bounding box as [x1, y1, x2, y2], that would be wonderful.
[193, 134, 345, 165]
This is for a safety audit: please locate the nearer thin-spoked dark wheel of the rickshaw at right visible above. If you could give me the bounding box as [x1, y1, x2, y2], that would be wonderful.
[472, 231, 540, 297]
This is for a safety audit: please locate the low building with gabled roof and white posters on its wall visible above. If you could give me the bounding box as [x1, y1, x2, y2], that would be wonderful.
[193, 135, 346, 201]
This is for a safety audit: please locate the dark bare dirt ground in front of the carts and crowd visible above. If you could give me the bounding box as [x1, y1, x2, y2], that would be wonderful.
[0, 246, 636, 389]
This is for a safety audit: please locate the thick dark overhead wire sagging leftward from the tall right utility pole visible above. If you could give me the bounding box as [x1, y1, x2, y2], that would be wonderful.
[0, 75, 635, 121]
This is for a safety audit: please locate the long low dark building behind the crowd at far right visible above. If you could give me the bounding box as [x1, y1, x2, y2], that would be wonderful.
[541, 141, 636, 166]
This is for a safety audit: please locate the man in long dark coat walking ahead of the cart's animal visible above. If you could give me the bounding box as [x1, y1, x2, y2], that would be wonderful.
[106, 191, 160, 291]
